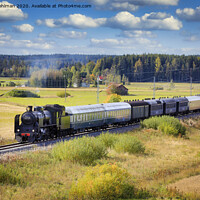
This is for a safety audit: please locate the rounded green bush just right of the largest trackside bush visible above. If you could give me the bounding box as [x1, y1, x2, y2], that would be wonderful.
[114, 135, 145, 154]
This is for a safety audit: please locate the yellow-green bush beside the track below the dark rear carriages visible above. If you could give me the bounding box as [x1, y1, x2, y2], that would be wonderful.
[142, 116, 186, 136]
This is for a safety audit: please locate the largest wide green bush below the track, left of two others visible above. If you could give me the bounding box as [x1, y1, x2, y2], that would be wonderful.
[52, 137, 107, 165]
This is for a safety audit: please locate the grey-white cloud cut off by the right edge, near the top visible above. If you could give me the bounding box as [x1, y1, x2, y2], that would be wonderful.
[176, 6, 200, 21]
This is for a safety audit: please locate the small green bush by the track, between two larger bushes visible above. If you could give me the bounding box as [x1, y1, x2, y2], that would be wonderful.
[97, 133, 117, 148]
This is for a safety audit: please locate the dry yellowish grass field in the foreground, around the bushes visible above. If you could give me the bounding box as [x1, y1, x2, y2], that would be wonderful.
[0, 120, 200, 200]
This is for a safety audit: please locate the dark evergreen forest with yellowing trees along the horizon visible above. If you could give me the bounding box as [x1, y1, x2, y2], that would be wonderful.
[0, 54, 200, 87]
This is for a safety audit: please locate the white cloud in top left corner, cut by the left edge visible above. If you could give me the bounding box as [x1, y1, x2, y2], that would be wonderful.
[0, 1, 28, 22]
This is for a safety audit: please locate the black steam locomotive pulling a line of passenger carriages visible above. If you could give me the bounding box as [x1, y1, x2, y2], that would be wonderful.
[14, 95, 200, 143]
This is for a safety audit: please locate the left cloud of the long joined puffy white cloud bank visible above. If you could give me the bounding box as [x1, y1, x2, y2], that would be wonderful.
[37, 14, 106, 29]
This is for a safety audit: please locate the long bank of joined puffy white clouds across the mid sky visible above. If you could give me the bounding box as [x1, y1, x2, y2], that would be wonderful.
[37, 11, 182, 30]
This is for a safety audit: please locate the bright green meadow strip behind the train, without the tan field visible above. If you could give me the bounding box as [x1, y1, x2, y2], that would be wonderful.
[0, 83, 200, 106]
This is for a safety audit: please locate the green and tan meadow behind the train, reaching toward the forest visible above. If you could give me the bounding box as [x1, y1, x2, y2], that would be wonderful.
[0, 79, 200, 139]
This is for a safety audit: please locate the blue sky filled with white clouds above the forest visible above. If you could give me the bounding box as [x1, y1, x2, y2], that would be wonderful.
[0, 0, 200, 55]
